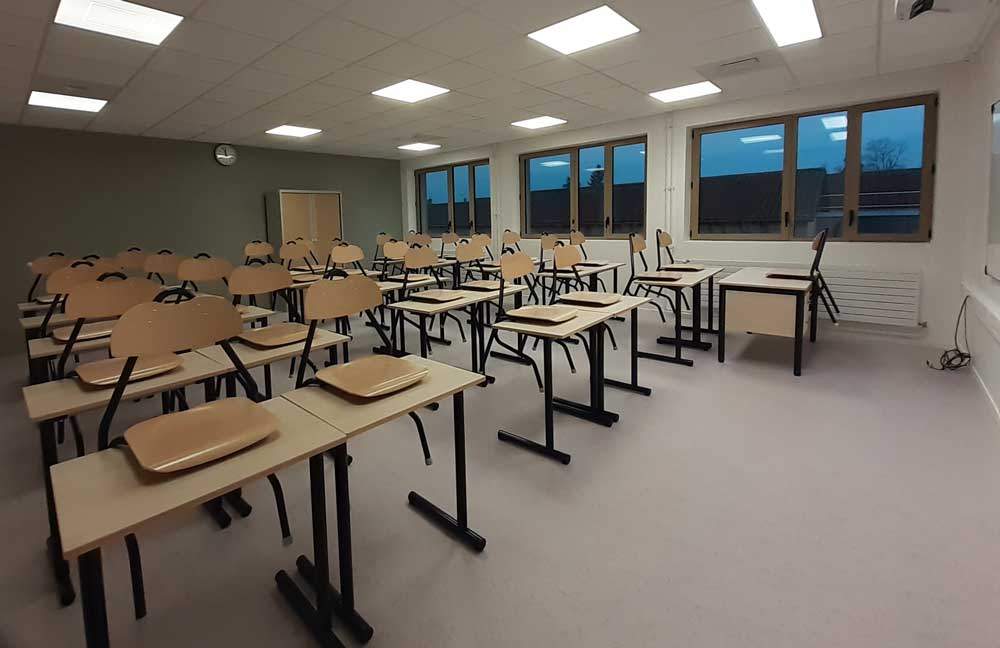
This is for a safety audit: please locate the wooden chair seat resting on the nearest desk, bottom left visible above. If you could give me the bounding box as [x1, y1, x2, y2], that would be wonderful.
[125, 398, 278, 473]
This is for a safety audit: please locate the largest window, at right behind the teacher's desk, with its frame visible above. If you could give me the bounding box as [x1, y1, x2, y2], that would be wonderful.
[691, 95, 937, 241]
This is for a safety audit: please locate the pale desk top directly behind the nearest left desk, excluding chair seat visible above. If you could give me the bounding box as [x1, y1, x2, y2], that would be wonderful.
[21, 351, 231, 423]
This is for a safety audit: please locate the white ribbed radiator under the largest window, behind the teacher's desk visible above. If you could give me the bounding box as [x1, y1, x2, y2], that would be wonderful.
[697, 260, 921, 327]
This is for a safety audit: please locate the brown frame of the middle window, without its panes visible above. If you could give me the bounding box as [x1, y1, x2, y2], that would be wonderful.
[517, 134, 649, 241]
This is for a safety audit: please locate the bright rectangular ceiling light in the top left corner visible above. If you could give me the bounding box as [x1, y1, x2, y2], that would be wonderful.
[56, 0, 184, 45]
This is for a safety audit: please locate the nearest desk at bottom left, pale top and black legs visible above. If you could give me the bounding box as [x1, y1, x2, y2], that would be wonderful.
[52, 398, 347, 648]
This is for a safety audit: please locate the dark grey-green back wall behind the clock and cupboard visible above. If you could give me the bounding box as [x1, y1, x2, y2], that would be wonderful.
[0, 125, 402, 353]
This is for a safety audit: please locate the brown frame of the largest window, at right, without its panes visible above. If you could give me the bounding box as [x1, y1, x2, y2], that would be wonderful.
[688, 93, 939, 243]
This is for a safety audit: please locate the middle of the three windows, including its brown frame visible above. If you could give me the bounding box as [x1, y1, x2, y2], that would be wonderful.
[520, 137, 646, 238]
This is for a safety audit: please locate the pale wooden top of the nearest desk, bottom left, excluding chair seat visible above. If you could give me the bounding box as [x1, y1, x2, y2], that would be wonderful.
[52, 398, 346, 559]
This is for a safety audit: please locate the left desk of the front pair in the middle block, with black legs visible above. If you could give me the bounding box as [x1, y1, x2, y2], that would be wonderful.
[493, 306, 618, 465]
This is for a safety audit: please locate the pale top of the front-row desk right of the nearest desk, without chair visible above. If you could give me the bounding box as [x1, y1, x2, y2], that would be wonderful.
[283, 355, 486, 437]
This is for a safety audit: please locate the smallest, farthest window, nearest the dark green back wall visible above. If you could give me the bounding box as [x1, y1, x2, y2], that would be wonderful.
[416, 160, 492, 236]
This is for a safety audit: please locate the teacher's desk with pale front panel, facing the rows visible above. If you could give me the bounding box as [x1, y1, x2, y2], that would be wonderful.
[719, 268, 818, 376]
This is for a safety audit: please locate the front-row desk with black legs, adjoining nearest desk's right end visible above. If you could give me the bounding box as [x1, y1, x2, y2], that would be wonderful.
[279, 356, 486, 642]
